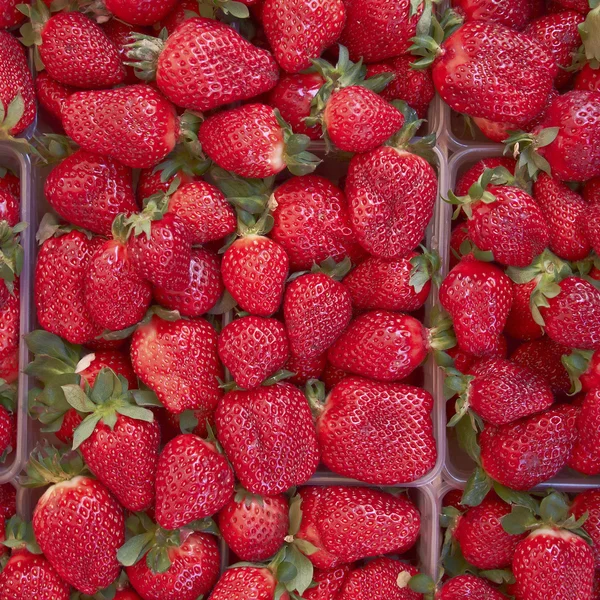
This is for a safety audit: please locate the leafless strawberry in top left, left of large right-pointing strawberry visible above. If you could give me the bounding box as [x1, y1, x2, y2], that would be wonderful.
[39, 12, 125, 90]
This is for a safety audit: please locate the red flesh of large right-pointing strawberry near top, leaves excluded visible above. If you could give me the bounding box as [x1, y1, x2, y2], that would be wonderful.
[156, 18, 279, 111]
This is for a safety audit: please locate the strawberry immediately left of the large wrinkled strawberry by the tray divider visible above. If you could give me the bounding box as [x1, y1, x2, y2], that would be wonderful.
[271, 175, 363, 271]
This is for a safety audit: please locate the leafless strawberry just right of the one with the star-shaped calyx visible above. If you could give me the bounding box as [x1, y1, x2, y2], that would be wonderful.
[155, 434, 233, 529]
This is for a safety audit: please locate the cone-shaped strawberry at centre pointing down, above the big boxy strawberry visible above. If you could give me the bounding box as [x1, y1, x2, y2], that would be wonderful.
[283, 263, 352, 359]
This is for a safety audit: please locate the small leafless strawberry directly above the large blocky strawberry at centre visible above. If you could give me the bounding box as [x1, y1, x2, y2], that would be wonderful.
[219, 315, 289, 389]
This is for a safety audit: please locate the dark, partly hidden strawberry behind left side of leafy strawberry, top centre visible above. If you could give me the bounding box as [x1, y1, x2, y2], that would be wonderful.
[269, 73, 325, 140]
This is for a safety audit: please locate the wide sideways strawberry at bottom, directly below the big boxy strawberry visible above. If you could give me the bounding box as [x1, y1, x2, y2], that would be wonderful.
[295, 486, 421, 569]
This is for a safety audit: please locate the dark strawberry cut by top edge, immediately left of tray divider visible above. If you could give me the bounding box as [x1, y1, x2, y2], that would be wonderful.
[340, 0, 422, 63]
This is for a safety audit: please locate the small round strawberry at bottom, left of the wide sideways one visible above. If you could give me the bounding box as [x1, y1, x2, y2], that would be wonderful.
[218, 488, 290, 564]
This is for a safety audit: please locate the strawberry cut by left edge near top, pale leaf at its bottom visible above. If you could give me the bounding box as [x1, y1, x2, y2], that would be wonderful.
[0, 31, 36, 135]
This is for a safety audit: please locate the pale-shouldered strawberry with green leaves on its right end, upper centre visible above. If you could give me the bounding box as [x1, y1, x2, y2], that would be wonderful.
[198, 104, 320, 178]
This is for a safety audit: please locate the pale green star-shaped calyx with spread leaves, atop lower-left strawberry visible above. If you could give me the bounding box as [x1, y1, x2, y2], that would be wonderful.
[62, 368, 160, 450]
